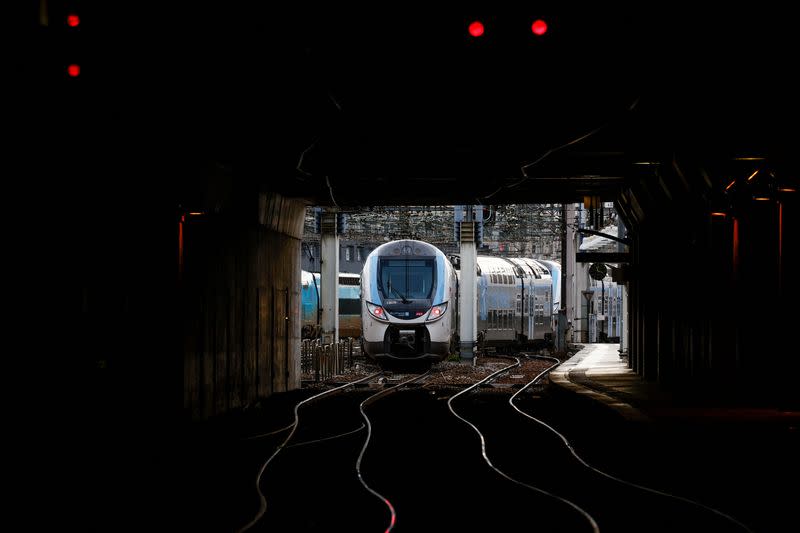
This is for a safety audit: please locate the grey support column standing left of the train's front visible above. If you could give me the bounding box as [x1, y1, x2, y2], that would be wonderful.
[319, 212, 339, 344]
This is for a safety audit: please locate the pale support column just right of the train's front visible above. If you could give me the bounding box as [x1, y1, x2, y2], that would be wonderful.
[458, 222, 478, 361]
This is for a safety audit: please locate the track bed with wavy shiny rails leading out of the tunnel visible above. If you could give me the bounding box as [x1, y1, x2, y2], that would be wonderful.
[172, 353, 764, 533]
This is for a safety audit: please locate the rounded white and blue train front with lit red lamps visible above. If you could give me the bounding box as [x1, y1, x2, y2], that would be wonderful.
[361, 240, 456, 361]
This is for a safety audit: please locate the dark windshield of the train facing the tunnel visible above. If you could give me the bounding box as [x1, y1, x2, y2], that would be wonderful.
[378, 258, 436, 302]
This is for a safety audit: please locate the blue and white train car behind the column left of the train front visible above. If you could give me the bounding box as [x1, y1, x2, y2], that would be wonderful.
[300, 270, 361, 339]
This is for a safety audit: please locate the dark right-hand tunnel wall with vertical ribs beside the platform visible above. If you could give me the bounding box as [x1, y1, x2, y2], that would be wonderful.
[618, 161, 798, 403]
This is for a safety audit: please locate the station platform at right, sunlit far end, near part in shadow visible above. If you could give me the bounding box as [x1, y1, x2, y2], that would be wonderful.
[550, 343, 800, 427]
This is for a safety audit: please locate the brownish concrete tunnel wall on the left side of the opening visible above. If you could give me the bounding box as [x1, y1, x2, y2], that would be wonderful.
[180, 193, 305, 419]
